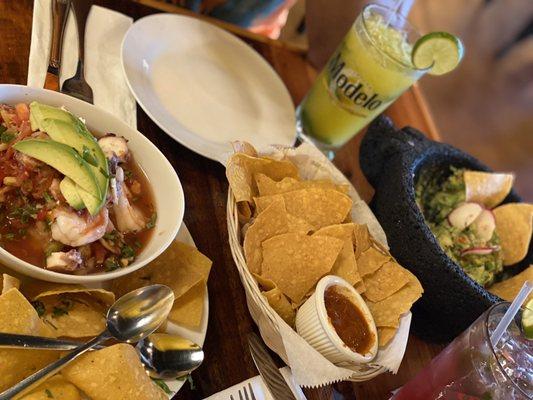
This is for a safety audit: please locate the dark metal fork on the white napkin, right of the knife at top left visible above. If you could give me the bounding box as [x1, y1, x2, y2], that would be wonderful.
[61, 0, 94, 104]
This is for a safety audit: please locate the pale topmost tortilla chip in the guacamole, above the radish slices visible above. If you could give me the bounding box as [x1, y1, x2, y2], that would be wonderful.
[463, 171, 514, 208]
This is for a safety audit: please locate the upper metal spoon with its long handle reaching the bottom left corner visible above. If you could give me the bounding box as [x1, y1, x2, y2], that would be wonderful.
[0, 285, 174, 400]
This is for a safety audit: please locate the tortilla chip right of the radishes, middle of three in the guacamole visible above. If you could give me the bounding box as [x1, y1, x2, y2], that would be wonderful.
[492, 203, 533, 266]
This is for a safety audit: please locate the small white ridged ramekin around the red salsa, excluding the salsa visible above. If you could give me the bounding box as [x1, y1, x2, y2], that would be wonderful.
[296, 275, 378, 365]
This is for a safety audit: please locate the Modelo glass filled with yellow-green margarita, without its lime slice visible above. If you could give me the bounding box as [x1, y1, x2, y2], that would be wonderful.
[298, 5, 427, 155]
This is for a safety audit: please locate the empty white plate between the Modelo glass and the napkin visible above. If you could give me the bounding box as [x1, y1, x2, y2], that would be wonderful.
[122, 14, 296, 160]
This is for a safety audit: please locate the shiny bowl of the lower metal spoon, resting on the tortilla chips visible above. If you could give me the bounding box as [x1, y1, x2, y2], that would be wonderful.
[137, 333, 204, 379]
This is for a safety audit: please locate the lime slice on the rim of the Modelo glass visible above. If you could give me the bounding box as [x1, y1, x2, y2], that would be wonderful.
[411, 32, 464, 75]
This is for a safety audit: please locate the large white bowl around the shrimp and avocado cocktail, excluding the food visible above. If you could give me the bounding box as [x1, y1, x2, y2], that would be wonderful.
[0, 85, 185, 283]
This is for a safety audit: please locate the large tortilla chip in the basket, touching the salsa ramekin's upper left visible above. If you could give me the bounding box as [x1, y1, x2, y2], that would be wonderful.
[261, 233, 344, 303]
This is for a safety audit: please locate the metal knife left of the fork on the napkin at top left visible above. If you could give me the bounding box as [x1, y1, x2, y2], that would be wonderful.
[44, 0, 70, 92]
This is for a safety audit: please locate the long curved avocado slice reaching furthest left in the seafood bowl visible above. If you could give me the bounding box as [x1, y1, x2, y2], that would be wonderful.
[13, 139, 105, 204]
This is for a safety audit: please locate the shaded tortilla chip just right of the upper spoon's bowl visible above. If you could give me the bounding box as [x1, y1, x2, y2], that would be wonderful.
[168, 282, 207, 328]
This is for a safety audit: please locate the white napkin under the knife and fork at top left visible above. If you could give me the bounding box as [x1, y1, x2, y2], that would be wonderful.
[28, 0, 137, 128]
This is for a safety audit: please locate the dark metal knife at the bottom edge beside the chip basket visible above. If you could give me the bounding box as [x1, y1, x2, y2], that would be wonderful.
[248, 333, 297, 400]
